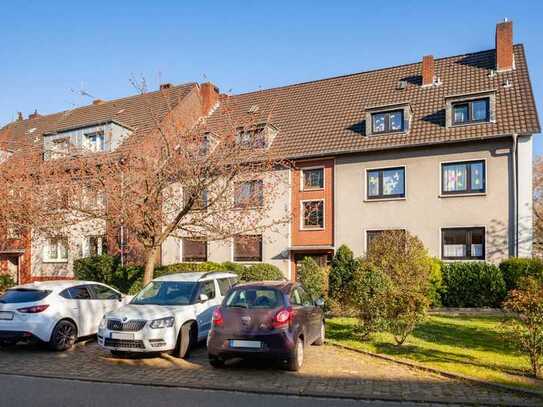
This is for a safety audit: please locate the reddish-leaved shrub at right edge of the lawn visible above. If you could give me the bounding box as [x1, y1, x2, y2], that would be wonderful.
[503, 277, 543, 378]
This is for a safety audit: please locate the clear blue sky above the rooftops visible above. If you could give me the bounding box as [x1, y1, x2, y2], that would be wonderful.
[0, 0, 543, 154]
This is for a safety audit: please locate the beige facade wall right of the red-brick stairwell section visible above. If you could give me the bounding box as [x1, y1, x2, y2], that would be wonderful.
[335, 138, 516, 262]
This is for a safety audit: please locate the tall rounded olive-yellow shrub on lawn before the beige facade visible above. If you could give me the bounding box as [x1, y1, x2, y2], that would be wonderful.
[367, 231, 433, 345]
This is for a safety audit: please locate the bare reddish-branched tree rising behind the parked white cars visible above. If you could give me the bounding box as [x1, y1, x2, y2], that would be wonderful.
[0, 87, 289, 283]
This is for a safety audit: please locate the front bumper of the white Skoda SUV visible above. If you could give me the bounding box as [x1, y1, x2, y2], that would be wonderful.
[98, 327, 177, 353]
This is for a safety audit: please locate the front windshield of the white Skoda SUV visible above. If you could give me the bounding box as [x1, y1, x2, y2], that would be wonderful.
[130, 281, 198, 305]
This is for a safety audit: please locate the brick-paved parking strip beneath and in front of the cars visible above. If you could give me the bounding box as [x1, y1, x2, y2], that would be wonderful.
[0, 341, 541, 406]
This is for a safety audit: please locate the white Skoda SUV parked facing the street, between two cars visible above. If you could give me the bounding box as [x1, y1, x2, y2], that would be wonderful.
[98, 272, 237, 358]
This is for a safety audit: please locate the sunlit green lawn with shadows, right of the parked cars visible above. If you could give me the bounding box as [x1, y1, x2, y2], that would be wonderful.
[326, 316, 543, 392]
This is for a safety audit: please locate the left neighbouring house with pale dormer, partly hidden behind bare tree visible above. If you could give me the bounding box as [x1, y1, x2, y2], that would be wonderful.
[0, 83, 219, 283]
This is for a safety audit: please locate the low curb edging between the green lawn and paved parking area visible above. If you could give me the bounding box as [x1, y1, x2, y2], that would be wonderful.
[326, 340, 543, 400]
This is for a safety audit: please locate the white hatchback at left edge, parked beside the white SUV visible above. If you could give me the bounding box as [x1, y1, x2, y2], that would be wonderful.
[0, 280, 129, 351]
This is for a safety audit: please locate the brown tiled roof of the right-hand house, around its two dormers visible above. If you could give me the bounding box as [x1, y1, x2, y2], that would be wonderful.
[208, 45, 540, 158]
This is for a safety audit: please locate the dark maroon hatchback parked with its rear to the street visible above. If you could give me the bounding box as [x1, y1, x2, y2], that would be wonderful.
[207, 281, 324, 371]
